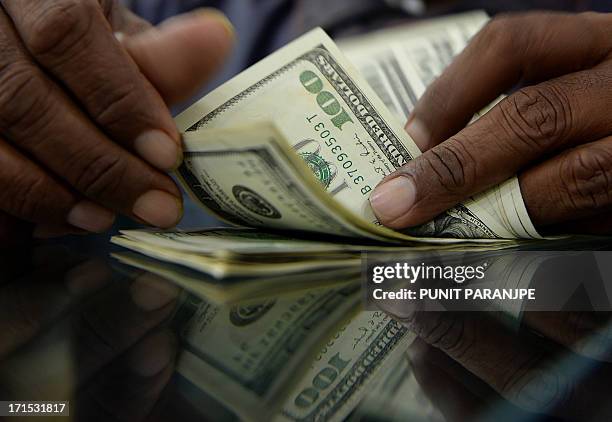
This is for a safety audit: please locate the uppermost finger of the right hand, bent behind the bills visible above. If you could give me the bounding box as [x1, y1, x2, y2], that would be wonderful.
[406, 12, 612, 151]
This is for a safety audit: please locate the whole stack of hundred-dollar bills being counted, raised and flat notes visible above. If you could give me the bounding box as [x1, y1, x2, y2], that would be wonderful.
[113, 13, 540, 278]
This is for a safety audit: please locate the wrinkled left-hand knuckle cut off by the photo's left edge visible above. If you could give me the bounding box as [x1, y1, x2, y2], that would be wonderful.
[0, 61, 53, 137]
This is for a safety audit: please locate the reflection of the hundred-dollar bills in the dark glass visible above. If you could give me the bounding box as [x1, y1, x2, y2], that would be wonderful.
[174, 286, 412, 421]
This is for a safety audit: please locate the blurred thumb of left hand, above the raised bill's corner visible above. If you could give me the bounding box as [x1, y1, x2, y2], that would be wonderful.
[122, 9, 234, 104]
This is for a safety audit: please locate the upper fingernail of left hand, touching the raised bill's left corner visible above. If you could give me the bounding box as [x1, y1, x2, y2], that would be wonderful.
[134, 130, 182, 170]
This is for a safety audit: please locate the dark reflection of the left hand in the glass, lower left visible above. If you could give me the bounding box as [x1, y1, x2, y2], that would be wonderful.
[0, 248, 178, 421]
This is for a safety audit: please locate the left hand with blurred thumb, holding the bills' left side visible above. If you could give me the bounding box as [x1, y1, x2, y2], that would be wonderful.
[0, 0, 232, 240]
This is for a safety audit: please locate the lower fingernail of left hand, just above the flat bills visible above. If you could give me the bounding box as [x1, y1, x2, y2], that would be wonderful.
[132, 190, 183, 228]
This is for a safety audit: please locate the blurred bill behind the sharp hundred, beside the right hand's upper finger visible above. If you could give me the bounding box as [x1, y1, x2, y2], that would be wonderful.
[337, 11, 489, 121]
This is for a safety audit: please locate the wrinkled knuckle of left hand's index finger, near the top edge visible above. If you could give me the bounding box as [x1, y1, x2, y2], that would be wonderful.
[24, 0, 98, 57]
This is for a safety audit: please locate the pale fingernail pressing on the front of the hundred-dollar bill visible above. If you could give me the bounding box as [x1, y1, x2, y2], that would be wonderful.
[370, 176, 416, 225]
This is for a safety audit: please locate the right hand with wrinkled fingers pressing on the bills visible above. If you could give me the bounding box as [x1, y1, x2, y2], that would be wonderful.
[371, 13, 612, 234]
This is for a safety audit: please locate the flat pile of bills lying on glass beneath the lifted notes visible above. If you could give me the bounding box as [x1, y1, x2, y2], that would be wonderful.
[111, 227, 520, 290]
